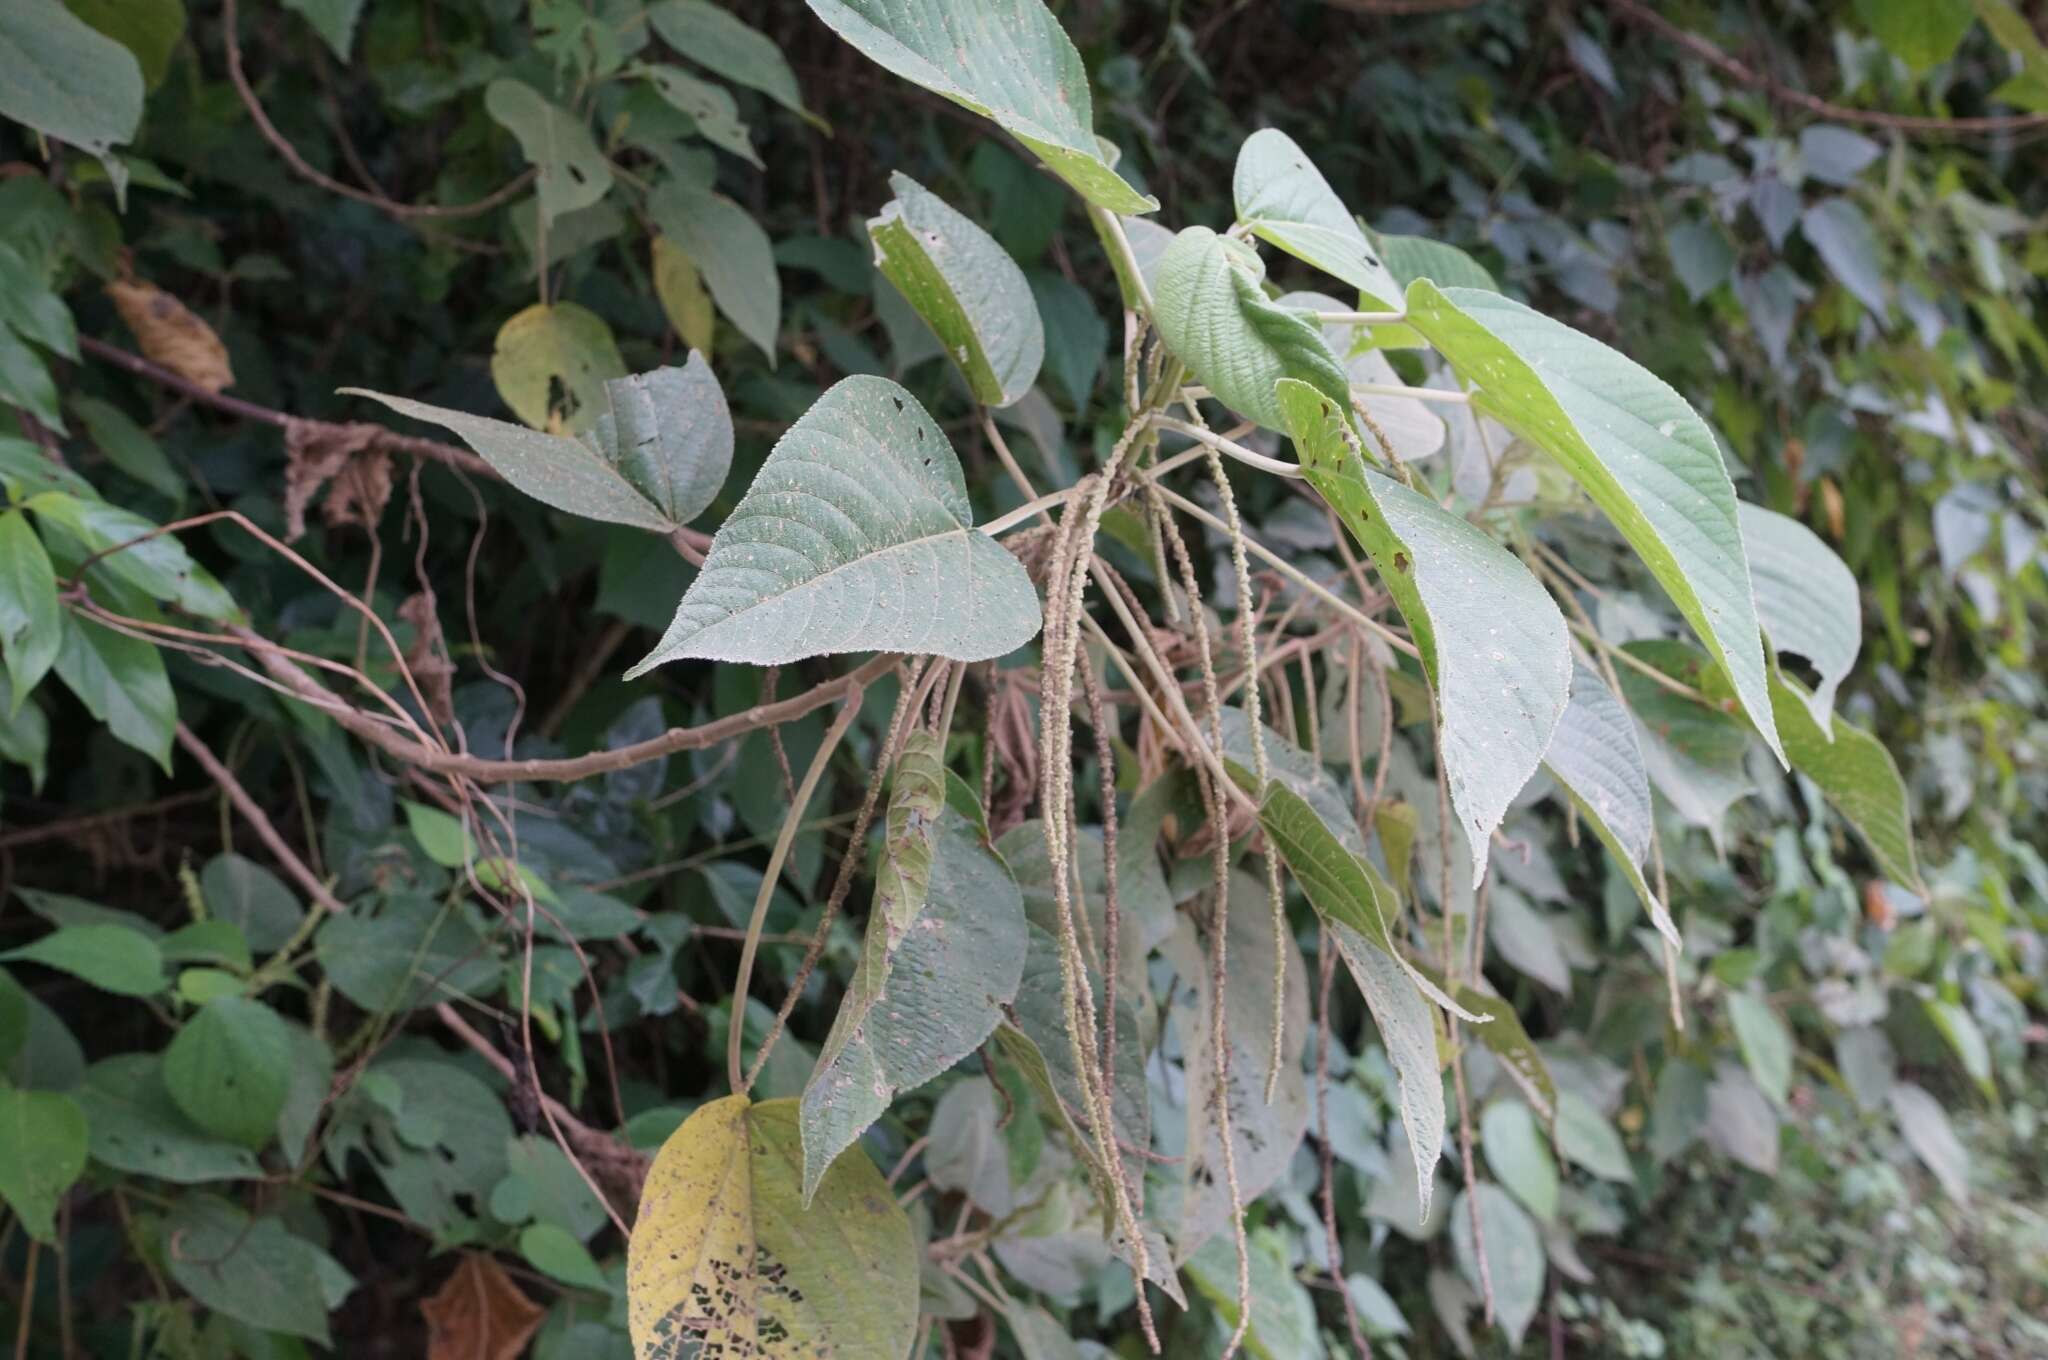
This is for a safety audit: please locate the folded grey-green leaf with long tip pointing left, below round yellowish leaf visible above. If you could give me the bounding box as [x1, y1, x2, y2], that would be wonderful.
[342, 350, 733, 533]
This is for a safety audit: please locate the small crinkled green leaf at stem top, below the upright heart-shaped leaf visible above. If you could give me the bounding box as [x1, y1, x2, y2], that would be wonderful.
[1153, 227, 1352, 430]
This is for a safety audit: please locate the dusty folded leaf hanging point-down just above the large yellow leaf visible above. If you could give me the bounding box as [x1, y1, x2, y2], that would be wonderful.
[799, 806, 1026, 1204]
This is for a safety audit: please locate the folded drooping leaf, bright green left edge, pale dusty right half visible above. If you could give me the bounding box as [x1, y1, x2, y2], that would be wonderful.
[1276, 379, 1571, 883]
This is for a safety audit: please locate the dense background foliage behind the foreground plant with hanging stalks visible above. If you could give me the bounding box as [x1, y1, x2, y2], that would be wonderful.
[0, 0, 2048, 1358]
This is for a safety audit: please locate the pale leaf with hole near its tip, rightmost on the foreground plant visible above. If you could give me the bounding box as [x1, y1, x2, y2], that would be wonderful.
[1739, 502, 1864, 746]
